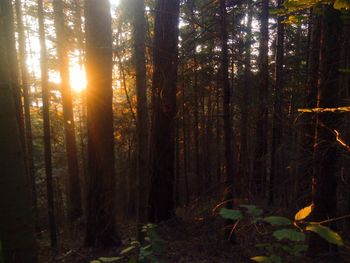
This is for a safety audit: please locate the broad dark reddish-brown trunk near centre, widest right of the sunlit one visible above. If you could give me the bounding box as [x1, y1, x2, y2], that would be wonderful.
[149, 0, 179, 222]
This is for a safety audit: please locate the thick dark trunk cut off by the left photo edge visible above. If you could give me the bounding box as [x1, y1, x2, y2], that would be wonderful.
[0, 1, 37, 263]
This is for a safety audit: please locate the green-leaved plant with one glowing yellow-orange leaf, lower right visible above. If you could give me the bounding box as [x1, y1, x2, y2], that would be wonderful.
[219, 204, 344, 263]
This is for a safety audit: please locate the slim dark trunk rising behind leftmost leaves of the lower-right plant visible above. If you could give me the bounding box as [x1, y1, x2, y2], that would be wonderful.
[220, 0, 235, 242]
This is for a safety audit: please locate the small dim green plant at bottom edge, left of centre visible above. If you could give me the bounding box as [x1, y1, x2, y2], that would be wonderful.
[90, 224, 164, 263]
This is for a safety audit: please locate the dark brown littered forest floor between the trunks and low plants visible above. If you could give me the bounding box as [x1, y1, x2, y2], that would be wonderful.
[41, 198, 350, 263]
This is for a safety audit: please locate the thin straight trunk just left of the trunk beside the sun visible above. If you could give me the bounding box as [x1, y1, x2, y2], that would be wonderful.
[38, 0, 57, 248]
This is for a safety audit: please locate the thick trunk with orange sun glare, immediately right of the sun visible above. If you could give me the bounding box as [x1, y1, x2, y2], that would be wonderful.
[85, 0, 120, 246]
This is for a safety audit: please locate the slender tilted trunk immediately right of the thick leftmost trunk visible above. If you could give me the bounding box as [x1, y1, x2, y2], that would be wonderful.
[15, 0, 40, 231]
